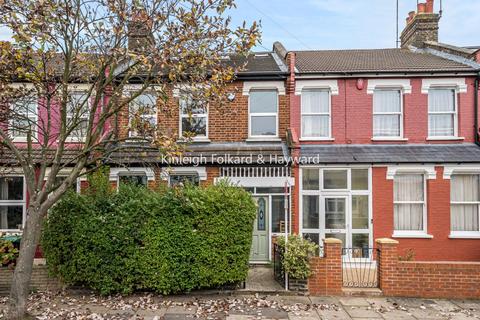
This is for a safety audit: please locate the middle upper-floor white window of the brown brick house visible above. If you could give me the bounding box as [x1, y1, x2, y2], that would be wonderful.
[179, 93, 208, 140]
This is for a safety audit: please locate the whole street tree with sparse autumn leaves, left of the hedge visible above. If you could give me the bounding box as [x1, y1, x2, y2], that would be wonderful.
[0, 0, 258, 319]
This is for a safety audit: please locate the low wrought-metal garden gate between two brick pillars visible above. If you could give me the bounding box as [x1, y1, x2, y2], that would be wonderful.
[342, 247, 378, 288]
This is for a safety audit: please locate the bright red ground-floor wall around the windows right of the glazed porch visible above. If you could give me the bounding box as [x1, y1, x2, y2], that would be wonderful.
[372, 166, 480, 261]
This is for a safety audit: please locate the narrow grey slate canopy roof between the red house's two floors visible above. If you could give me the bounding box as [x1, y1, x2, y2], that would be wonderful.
[300, 143, 480, 164]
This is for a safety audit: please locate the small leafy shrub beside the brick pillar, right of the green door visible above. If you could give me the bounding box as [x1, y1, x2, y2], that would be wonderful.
[278, 235, 318, 279]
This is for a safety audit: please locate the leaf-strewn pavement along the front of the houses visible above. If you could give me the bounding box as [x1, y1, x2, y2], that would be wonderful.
[0, 292, 480, 320]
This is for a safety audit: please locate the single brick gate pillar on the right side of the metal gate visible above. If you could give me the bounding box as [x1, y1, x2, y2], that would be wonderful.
[375, 238, 398, 295]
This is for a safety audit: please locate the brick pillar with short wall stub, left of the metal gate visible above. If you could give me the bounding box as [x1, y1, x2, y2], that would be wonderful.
[308, 239, 342, 295]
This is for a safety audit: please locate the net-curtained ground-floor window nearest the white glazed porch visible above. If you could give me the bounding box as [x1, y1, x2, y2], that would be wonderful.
[394, 174, 424, 231]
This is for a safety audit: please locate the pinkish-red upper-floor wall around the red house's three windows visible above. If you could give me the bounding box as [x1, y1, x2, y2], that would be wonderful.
[290, 77, 475, 144]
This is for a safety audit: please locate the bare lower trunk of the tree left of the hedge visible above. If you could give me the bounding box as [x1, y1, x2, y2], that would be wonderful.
[8, 206, 43, 320]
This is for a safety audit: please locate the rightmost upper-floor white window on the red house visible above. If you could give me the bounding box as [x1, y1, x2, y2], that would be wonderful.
[428, 87, 458, 138]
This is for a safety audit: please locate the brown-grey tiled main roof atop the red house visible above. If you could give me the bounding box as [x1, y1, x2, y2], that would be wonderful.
[295, 49, 475, 73]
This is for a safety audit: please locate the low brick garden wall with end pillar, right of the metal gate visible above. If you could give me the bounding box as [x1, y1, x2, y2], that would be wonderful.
[376, 239, 480, 299]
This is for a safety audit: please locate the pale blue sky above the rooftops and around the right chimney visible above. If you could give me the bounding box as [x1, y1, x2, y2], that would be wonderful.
[0, 0, 480, 50]
